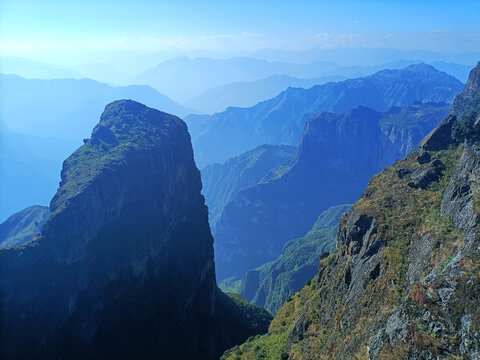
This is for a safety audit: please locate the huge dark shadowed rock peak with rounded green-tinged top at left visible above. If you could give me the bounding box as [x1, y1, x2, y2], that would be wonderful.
[0, 100, 265, 359]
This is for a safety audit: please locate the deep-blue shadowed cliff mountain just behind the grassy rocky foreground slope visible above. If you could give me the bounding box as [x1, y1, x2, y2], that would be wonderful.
[215, 103, 448, 280]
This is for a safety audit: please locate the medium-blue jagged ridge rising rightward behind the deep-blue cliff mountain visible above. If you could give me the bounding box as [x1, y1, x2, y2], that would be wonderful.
[185, 64, 463, 168]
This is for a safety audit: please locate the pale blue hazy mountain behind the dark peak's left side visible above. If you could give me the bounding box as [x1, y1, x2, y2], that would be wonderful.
[0, 74, 192, 219]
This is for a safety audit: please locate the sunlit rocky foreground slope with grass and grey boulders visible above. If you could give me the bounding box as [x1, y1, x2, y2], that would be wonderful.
[224, 63, 480, 360]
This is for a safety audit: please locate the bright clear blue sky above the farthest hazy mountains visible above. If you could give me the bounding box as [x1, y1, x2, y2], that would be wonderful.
[0, 0, 480, 63]
